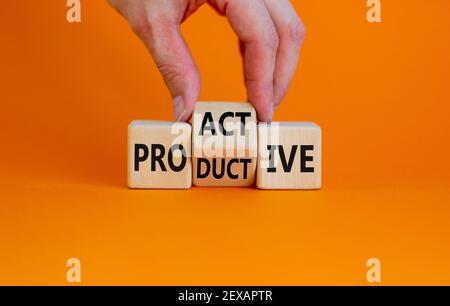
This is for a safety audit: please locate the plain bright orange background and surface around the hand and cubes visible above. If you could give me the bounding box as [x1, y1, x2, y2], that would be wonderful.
[0, 0, 450, 285]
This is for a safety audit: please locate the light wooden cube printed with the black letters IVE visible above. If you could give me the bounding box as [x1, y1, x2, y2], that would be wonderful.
[256, 122, 322, 189]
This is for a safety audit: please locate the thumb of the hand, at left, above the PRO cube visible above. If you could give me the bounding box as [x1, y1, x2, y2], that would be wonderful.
[134, 18, 200, 121]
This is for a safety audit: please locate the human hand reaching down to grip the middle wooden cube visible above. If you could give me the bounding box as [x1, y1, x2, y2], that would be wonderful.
[108, 0, 305, 122]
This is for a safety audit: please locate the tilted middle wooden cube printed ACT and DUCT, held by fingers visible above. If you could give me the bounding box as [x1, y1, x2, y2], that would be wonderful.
[192, 102, 258, 187]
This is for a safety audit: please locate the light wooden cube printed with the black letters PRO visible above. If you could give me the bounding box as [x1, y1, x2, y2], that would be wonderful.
[128, 121, 192, 189]
